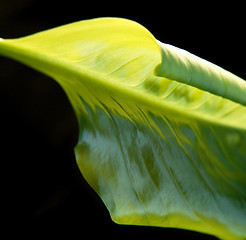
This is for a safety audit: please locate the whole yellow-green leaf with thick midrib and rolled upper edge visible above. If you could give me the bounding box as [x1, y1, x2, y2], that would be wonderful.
[0, 18, 246, 240]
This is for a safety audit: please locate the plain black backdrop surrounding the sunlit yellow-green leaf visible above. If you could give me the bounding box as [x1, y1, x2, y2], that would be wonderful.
[0, 0, 246, 239]
